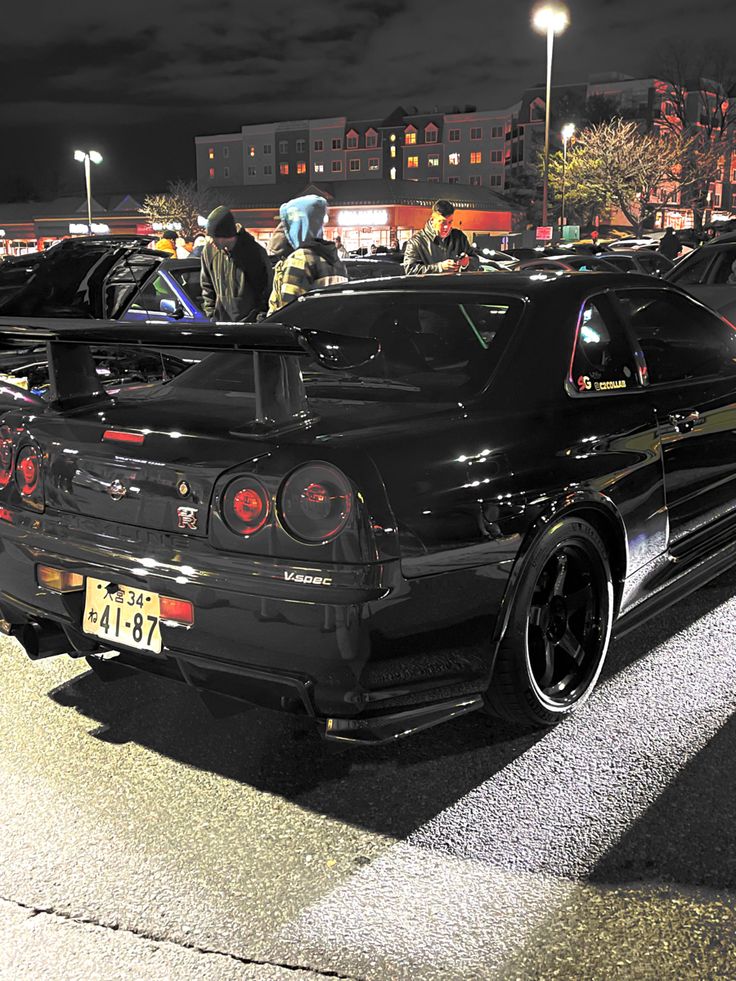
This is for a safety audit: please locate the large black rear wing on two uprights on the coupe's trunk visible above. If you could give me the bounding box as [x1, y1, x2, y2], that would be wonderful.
[0, 317, 380, 433]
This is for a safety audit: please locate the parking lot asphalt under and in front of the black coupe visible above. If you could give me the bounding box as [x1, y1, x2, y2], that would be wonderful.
[0, 573, 736, 981]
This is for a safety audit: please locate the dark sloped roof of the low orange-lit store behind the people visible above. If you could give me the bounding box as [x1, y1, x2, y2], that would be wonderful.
[227, 178, 520, 211]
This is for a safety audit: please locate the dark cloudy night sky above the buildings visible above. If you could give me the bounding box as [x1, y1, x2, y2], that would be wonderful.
[0, 0, 736, 201]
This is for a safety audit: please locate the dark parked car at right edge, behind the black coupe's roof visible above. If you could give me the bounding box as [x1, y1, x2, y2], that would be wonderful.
[664, 235, 736, 322]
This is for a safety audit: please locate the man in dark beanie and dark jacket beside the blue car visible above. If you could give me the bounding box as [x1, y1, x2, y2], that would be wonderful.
[200, 205, 271, 323]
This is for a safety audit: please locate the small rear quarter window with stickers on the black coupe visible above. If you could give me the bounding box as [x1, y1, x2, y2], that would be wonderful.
[568, 300, 641, 395]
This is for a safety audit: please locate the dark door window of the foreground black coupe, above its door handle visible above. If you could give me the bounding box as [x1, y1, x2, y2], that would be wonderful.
[617, 289, 736, 385]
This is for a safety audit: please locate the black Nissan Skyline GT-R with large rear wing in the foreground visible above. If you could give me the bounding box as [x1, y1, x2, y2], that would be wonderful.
[0, 272, 736, 742]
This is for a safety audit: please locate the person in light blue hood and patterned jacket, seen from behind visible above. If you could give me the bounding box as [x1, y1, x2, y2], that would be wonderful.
[268, 194, 348, 314]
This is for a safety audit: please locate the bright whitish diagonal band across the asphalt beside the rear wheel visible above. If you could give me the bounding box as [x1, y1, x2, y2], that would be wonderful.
[283, 600, 736, 978]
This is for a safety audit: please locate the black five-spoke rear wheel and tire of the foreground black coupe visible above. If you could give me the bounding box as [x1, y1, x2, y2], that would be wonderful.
[486, 516, 614, 726]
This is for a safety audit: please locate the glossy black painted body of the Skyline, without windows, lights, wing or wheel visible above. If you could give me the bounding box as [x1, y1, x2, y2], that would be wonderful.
[0, 273, 736, 741]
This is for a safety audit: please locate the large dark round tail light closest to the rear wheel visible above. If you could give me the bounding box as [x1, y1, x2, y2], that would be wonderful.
[279, 463, 353, 545]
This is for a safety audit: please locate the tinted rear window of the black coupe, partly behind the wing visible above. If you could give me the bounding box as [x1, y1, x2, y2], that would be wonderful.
[175, 293, 523, 401]
